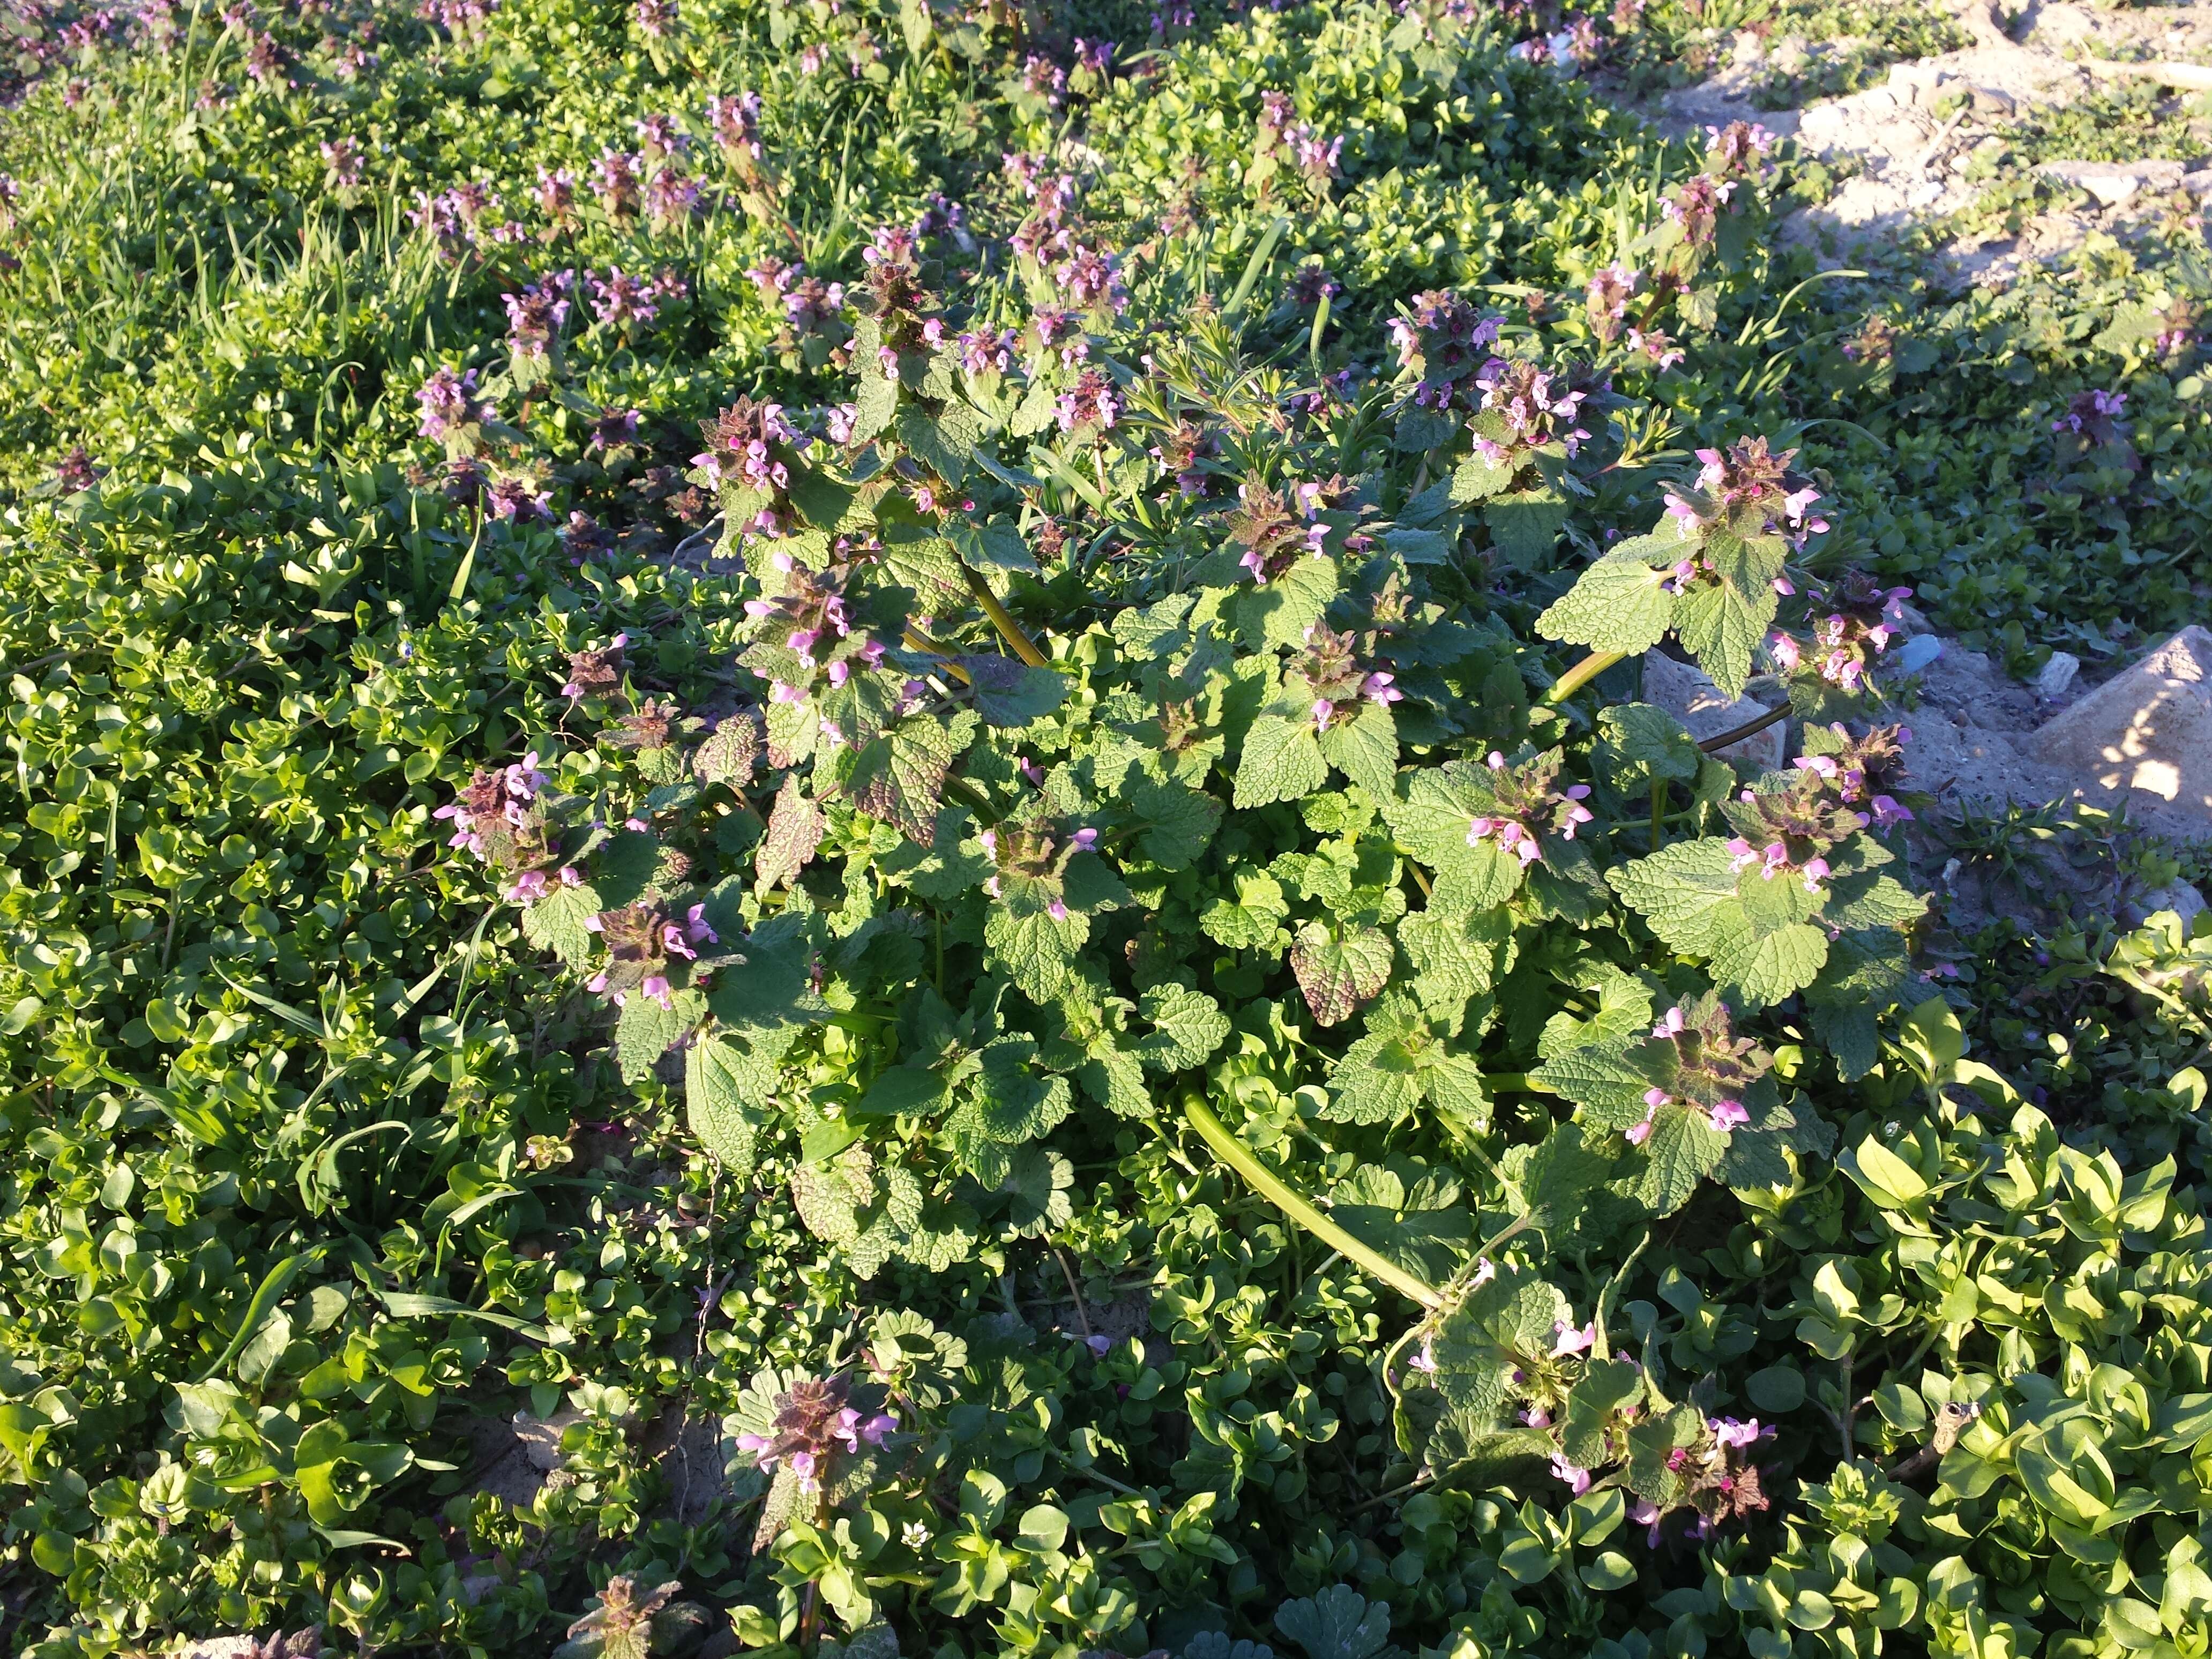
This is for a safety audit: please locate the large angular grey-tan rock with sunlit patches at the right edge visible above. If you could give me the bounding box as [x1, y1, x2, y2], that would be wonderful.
[2031, 626, 2212, 827]
